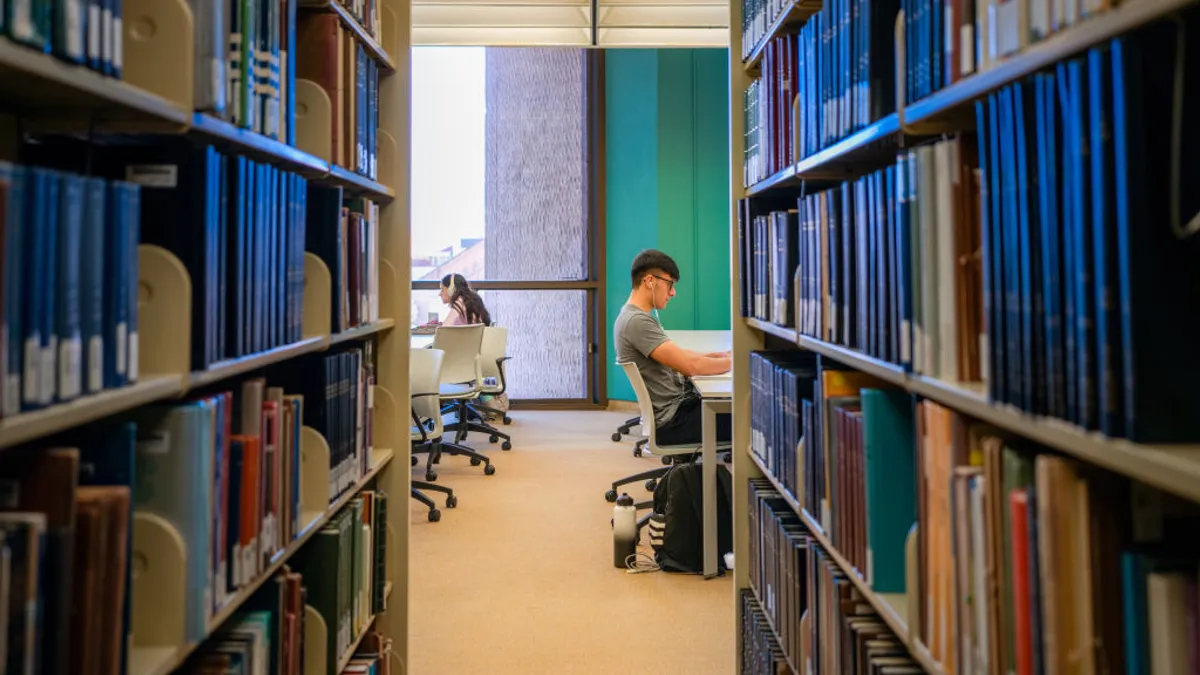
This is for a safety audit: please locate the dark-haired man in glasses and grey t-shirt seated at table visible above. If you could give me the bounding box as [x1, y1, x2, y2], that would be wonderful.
[613, 249, 731, 446]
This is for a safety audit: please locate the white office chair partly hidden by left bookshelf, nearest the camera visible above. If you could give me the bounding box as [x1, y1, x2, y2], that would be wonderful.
[408, 348, 496, 491]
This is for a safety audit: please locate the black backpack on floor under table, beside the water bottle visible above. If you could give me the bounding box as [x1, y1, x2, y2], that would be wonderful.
[649, 462, 733, 574]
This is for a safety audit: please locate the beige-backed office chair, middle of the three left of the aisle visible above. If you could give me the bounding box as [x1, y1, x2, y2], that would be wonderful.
[432, 323, 496, 476]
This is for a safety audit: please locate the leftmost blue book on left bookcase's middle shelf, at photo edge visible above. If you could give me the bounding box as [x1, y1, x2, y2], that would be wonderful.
[0, 161, 26, 417]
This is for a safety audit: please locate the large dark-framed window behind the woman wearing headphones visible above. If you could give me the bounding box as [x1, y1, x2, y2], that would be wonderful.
[412, 47, 599, 400]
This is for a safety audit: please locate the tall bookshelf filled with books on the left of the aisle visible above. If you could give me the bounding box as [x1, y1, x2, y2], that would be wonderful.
[0, 0, 410, 675]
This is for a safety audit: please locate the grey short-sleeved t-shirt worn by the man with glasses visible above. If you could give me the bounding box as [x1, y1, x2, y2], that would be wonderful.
[612, 304, 688, 424]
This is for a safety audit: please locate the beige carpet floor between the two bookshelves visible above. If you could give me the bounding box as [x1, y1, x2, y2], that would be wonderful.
[409, 411, 736, 675]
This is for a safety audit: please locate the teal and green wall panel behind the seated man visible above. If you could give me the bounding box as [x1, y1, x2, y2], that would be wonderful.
[605, 49, 730, 400]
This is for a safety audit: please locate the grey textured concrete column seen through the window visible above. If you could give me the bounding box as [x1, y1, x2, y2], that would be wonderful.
[484, 48, 587, 399]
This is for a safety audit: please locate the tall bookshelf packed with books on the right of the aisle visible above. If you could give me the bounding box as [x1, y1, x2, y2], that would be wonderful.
[730, 0, 1200, 674]
